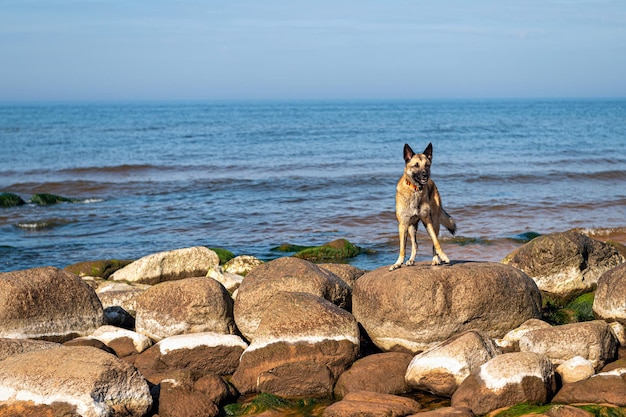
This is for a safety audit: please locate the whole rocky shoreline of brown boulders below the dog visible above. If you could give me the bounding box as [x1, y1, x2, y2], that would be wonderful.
[0, 231, 626, 417]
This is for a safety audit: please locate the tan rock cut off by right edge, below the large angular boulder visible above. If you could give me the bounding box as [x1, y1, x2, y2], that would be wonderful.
[593, 263, 626, 324]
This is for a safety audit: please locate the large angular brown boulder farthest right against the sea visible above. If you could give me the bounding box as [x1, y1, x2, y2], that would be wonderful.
[502, 231, 624, 305]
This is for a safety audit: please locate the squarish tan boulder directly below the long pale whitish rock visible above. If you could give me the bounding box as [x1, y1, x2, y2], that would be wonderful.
[135, 278, 235, 341]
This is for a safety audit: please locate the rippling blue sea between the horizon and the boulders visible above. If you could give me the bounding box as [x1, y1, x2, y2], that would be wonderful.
[0, 99, 626, 272]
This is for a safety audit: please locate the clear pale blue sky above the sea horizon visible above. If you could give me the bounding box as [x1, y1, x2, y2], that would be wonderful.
[0, 0, 626, 101]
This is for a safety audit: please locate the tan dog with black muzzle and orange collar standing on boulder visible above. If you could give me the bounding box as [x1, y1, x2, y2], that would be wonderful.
[389, 143, 456, 271]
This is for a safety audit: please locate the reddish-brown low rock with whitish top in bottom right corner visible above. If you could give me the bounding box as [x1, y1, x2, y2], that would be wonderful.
[552, 368, 626, 407]
